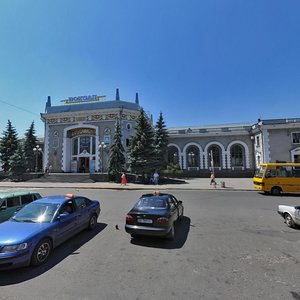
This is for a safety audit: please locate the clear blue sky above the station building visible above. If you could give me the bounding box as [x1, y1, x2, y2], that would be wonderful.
[0, 0, 300, 136]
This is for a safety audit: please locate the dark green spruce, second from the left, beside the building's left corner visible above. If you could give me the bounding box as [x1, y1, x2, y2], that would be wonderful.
[23, 122, 37, 171]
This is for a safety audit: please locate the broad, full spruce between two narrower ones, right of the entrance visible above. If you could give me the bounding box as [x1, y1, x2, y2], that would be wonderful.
[129, 109, 157, 174]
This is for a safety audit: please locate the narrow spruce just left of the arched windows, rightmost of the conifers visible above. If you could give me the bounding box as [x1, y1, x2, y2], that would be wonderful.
[154, 112, 168, 170]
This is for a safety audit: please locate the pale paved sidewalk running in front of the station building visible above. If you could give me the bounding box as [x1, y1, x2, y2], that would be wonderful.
[0, 178, 255, 191]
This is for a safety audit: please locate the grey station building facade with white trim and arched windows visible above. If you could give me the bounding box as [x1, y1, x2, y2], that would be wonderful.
[41, 89, 300, 176]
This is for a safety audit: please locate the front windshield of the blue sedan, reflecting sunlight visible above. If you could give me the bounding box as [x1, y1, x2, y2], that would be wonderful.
[11, 202, 59, 223]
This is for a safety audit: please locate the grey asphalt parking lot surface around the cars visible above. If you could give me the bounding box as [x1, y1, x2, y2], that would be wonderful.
[0, 189, 300, 300]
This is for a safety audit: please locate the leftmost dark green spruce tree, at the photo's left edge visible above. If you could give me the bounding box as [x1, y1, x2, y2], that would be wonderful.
[0, 120, 18, 172]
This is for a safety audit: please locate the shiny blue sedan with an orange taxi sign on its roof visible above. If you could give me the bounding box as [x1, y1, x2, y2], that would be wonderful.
[0, 194, 100, 270]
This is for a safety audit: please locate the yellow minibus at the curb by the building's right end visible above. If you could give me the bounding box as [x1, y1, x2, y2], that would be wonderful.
[253, 163, 300, 195]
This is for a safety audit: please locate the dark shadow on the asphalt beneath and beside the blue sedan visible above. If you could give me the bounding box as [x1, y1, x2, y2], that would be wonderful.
[0, 223, 107, 286]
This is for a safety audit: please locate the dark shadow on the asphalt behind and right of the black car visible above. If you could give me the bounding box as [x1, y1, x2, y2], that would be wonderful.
[131, 216, 191, 249]
